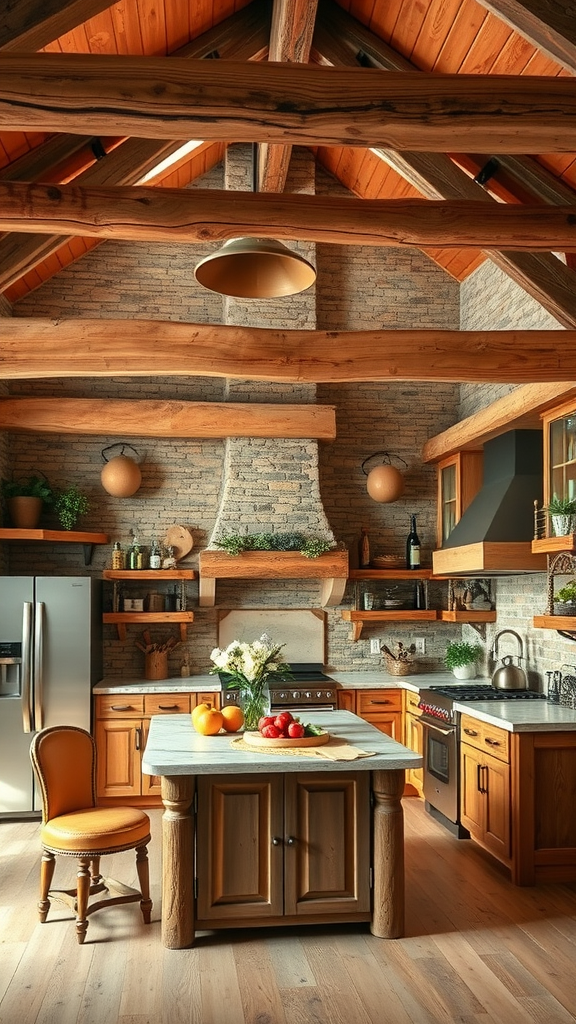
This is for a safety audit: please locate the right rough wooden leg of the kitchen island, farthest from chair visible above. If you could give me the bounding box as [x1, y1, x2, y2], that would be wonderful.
[370, 769, 404, 939]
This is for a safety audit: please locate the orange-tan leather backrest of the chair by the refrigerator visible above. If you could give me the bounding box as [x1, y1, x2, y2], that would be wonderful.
[30, 725, 96, 822]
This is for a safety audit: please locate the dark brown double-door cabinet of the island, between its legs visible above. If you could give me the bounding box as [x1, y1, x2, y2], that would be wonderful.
[196, 772, 370, 928]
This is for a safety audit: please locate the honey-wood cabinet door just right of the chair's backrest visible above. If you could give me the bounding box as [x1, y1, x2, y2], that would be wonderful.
[95, 719, 143, 797]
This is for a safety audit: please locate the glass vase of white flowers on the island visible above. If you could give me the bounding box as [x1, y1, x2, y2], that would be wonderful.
[210, 633, 290, 731]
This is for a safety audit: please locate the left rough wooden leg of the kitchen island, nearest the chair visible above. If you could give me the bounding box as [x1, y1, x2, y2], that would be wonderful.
[162, 775, 196, 949]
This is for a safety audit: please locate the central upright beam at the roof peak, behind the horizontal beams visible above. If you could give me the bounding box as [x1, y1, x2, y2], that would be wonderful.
[256, 0, 318, 193]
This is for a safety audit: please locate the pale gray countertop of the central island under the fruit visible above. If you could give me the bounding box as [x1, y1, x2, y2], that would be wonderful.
[142, 711, 422, 775]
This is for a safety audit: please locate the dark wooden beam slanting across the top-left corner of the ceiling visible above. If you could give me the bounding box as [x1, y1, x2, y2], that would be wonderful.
[0, 0, 110, 51]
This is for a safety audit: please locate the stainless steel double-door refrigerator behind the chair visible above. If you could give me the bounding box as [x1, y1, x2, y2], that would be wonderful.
[0, 577, 102, 817]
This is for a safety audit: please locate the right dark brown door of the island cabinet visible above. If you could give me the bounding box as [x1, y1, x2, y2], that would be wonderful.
[284, 772, 370, 916]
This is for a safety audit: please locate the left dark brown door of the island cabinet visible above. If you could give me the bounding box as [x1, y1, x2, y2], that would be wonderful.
[197, 775, 284, 921]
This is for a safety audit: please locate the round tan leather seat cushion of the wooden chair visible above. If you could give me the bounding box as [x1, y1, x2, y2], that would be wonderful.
[41, 807, 150, 855]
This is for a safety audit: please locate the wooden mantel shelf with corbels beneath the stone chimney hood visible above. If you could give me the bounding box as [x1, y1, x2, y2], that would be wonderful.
[199, 550, 348, 607]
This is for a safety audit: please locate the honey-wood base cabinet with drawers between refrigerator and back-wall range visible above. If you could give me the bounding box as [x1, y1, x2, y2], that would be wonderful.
[94, 693, 217, 807]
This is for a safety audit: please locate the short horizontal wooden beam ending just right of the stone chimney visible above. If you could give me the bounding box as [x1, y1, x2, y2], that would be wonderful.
[0, 396, 336, 440]
